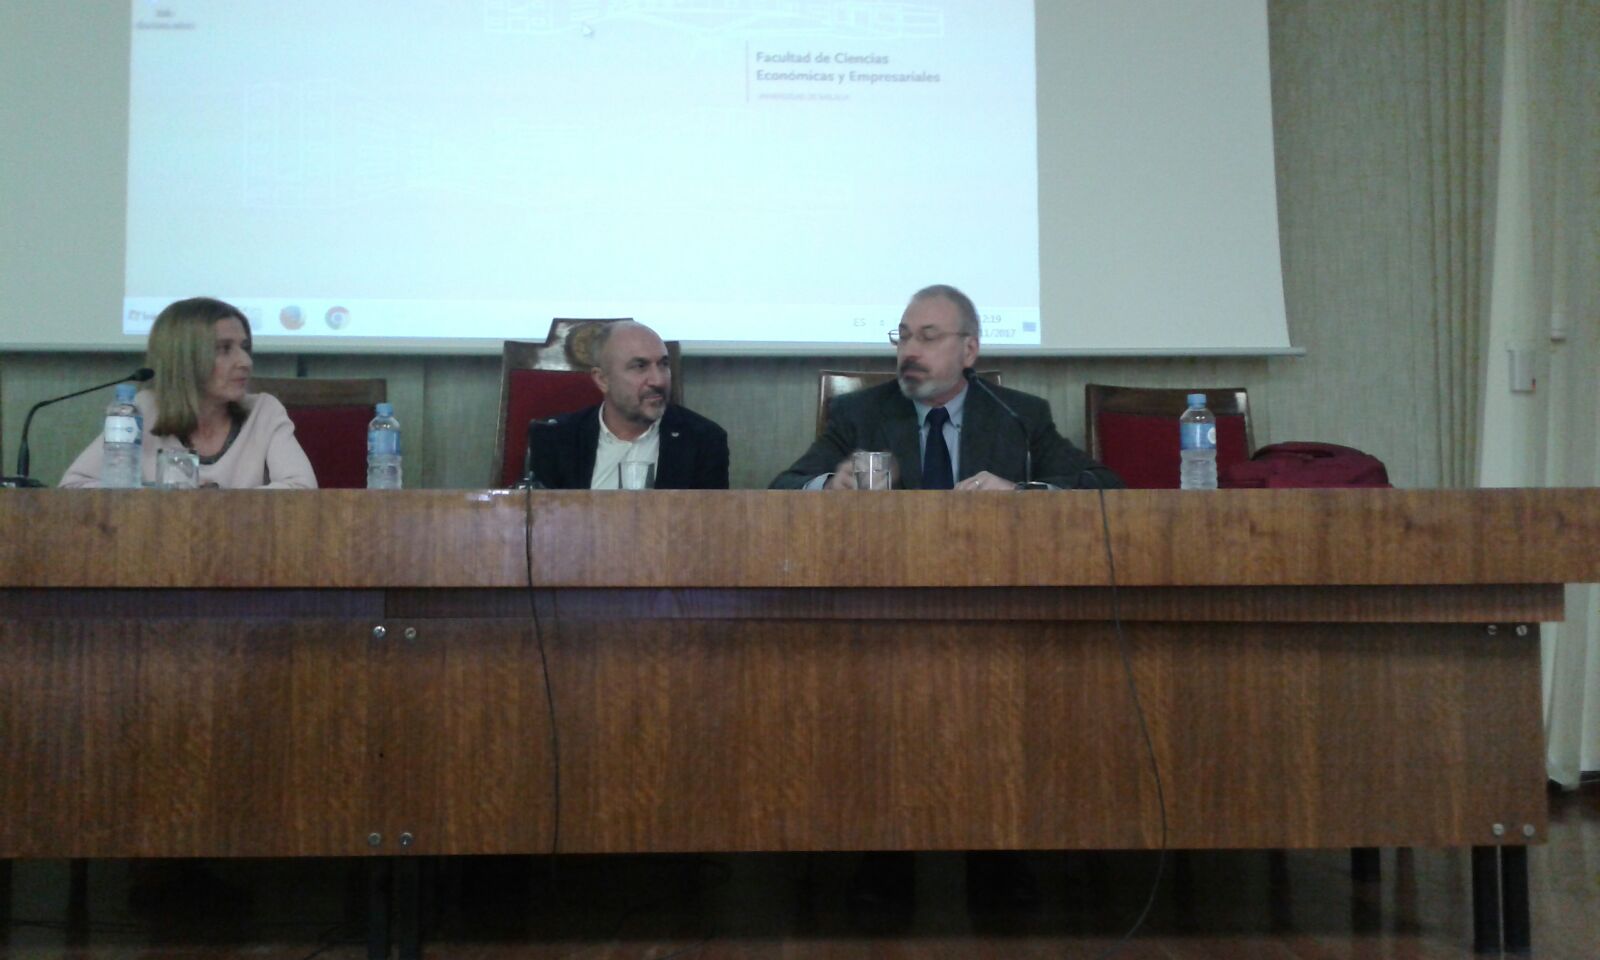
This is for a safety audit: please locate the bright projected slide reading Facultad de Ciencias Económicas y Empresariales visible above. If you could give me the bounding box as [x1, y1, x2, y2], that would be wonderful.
[123, 0, 1040, 349]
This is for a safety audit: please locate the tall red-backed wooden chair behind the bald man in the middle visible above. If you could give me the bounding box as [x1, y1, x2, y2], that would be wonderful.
[490, 317, 683, 488]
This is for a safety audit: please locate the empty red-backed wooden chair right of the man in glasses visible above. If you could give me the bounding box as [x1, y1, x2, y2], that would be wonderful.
[1083, 384, 1256, 490]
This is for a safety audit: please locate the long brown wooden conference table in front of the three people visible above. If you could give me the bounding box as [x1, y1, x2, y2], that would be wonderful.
[0, 490, 1600, 938]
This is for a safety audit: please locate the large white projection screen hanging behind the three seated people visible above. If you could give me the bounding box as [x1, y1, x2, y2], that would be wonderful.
[0, 0, 1290, 354]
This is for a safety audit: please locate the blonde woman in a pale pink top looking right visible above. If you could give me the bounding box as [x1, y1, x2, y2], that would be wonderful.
[61, 296, 317, 490]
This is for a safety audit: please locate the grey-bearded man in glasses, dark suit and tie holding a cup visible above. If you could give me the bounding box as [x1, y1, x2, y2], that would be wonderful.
[773, 285, 1122, 490]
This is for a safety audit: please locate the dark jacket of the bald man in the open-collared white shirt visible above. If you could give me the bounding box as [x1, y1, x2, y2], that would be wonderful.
[528, 403, 728, 490]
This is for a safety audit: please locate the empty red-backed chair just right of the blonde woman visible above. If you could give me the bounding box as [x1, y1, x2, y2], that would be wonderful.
[251, 376, 389, 490]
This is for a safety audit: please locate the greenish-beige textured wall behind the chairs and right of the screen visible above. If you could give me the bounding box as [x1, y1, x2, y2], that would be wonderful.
[0, 0, 1478, 486]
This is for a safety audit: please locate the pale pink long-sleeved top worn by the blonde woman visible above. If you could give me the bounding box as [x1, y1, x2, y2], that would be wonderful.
[61, 390, 317, 490]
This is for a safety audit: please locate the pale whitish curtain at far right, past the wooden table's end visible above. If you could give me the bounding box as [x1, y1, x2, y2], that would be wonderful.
[1480, 0, 1600, 787]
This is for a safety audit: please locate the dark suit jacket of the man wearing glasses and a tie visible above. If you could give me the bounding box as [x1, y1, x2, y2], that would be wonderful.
[773, 381, 1122, 490]
